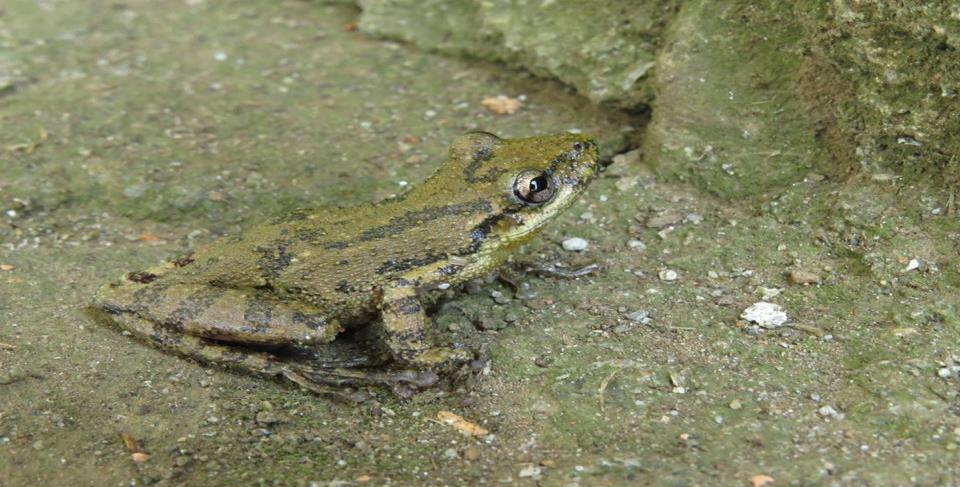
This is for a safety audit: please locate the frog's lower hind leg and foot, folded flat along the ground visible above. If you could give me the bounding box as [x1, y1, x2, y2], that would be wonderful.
[92, 310, 437, 401]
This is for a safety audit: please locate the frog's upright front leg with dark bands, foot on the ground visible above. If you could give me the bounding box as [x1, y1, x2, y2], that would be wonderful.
[380, 279, 470, 368]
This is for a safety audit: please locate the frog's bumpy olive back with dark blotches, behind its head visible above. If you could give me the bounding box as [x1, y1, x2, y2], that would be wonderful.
[175, 194, 498, 307]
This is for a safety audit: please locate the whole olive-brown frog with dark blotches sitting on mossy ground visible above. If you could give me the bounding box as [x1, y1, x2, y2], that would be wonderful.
[92, 132, 601, 393]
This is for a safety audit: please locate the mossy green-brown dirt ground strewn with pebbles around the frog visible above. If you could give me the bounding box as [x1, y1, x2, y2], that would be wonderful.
[0, 0, 960, 486]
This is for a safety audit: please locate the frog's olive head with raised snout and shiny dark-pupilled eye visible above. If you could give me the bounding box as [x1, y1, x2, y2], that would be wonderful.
[448, 132, 600, 247]
